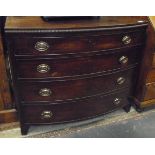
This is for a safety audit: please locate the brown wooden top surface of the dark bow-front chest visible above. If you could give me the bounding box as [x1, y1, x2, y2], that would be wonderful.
[5, 16, 147, 30]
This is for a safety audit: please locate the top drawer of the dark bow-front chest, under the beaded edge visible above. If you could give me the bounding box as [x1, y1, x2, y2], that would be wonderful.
[13, 31, 145, 56]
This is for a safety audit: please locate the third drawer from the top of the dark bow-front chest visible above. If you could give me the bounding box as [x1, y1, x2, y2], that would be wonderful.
[19, 69, 136, 103]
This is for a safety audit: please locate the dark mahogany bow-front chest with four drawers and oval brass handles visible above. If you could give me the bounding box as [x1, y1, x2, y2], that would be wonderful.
[5, 17, 148, 134]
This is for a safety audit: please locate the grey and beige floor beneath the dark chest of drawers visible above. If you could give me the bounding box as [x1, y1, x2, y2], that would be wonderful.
[0, 108, 155, 138]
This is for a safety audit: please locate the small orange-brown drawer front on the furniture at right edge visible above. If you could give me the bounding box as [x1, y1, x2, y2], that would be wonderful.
[144, 83, 155, 101]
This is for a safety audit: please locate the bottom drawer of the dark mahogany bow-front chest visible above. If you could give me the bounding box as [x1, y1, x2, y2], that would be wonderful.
[22, 90, 129, 124]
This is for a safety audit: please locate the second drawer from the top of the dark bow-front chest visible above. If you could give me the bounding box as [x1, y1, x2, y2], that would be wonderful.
[16, 47, 141, 79]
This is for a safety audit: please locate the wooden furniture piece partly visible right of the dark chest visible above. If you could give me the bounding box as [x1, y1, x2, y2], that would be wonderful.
[135, 17, 155, 111]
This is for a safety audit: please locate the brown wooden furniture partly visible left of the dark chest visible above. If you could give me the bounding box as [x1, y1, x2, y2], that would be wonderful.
[0, 16, 17, 123]
